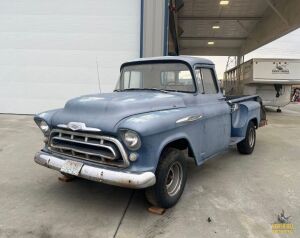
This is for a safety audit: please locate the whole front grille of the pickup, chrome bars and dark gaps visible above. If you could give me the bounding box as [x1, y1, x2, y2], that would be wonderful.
[48, 129, 129, 167]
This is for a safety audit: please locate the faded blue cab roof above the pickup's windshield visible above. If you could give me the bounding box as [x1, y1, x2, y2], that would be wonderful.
[121, 56, 214, 68]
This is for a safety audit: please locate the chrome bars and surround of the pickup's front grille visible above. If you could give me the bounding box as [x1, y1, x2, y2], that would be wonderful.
[48, 129, 130, 167]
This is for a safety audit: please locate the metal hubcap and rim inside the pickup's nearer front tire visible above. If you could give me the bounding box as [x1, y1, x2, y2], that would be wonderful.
[166, 162, 183, 196]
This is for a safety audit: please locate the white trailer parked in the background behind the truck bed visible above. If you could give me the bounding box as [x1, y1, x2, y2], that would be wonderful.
[223, 59, 300, 112]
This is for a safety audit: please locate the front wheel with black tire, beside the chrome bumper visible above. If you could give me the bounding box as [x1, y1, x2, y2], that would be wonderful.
[145, 148, 187, 208]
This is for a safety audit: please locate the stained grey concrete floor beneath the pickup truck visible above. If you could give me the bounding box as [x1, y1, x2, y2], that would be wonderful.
[0, 104, 300, 238]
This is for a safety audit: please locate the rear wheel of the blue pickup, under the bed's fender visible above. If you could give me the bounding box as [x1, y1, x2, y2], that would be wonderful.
[237, 121, 256, 154]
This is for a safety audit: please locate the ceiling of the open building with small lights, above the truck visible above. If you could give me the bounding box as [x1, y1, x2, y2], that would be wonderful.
[174, 0, 300, 55]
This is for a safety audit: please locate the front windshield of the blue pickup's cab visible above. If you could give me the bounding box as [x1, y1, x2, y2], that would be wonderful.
[116, 63, 196, 92]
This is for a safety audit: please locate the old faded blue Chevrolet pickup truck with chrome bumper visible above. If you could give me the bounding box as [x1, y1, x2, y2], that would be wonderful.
[34, 56, 261, 208]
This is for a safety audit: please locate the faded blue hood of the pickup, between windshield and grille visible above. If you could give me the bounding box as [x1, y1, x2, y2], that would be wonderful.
[52, 91, 185, 132]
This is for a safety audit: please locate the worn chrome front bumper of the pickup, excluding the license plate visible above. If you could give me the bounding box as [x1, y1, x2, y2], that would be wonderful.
[34, 151, 156, 188]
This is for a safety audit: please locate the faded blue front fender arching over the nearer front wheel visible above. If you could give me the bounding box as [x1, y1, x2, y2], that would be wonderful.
[117, 108, 201, 172]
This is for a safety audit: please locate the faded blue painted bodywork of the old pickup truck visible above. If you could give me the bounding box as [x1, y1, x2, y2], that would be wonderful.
[35, 57, 260, 175]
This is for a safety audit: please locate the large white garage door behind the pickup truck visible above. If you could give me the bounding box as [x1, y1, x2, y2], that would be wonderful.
[0, 0, 141, 114]
